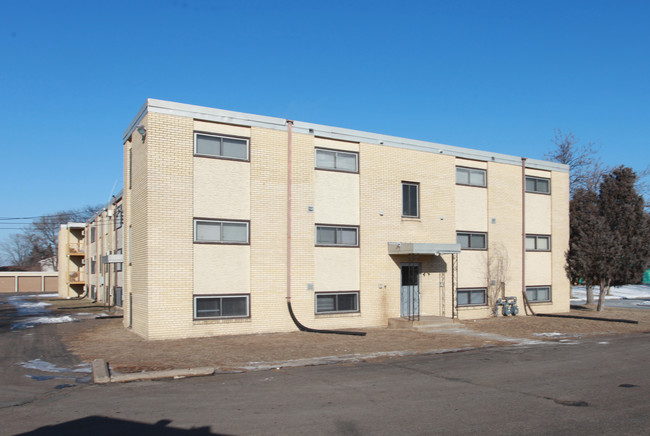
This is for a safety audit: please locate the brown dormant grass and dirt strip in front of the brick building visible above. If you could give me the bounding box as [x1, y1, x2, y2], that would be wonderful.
[49, 299, 650, 372]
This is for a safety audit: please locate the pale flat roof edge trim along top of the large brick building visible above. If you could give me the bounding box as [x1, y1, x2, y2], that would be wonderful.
[122, 98, 569, 172]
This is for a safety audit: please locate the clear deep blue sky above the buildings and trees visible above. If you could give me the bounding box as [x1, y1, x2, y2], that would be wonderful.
[0, 0, 650, 247]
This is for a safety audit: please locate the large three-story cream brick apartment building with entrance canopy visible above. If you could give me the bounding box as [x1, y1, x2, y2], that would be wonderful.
[120, 99, 570, 339]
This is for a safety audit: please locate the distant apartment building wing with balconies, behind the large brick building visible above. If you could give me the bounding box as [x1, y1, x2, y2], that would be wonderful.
[59, 193, 124, 308]
